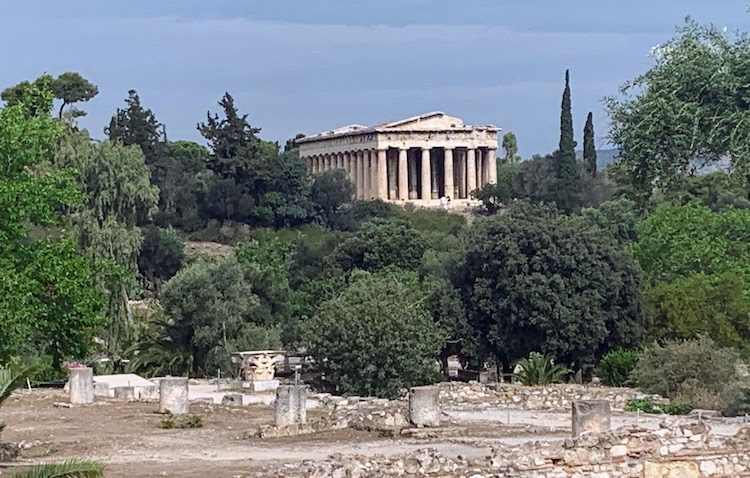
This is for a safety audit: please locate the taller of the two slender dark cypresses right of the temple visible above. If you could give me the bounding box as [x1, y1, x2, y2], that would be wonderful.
[554, 70, 580, 212]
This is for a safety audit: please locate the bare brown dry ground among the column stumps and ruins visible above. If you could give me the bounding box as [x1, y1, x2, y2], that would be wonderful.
[0, 390, 739, 478]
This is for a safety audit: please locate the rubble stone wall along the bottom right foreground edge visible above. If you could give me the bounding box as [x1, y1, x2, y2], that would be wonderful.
[265, 422, 750, 478]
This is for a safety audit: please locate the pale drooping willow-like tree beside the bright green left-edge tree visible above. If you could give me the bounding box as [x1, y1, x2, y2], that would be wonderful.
[53, 128, 159, 358]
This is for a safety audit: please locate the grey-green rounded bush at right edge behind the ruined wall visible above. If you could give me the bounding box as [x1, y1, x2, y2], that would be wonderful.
[631, 336, 748, 414]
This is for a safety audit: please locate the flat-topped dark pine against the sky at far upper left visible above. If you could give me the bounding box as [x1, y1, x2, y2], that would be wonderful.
[0, 72, 99, 118]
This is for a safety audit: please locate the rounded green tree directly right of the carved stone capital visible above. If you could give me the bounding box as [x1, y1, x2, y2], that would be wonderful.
[303, 272, 445, 398]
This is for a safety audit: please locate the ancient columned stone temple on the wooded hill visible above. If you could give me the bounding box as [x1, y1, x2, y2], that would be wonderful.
[298, 112, 499, 205]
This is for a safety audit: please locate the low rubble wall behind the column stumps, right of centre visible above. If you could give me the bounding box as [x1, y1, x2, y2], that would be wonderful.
[440, 382, 664, 411]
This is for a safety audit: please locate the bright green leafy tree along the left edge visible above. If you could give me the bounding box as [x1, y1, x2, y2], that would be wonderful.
[0, 86, 102, 368]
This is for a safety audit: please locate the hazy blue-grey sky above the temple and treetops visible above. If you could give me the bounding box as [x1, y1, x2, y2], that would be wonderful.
[0, 0, 750, 157]
